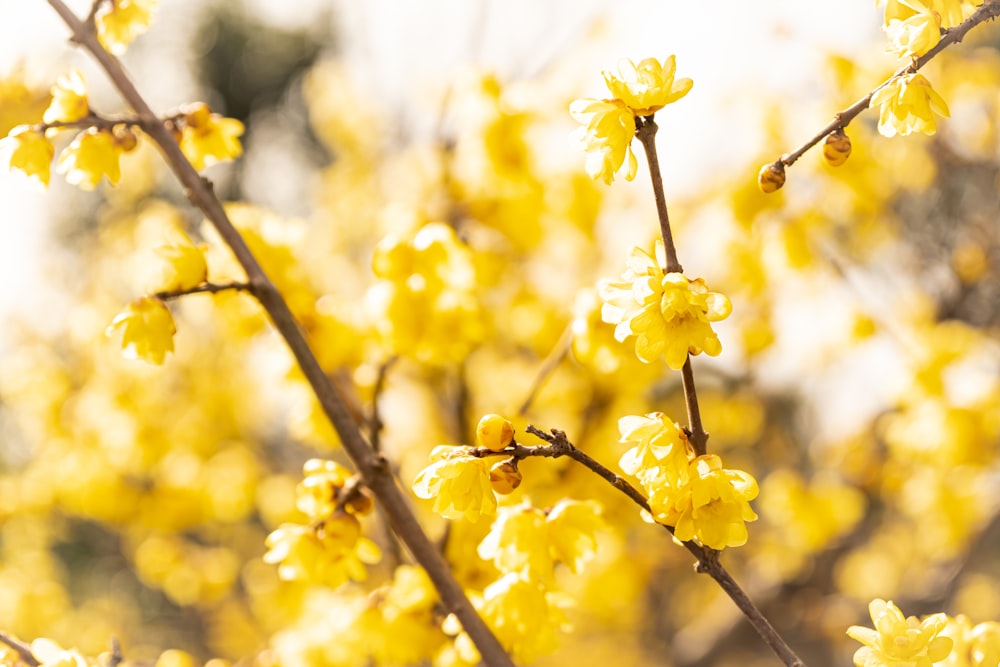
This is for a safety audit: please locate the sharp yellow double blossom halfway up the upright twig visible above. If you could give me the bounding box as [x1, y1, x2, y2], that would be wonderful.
[597, 241, 732, 369]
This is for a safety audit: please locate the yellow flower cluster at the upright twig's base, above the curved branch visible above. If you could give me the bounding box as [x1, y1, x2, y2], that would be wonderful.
[618, 412, 758, 549]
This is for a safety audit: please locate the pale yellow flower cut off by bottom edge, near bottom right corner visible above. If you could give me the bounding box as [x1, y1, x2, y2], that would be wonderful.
[847, 599, 953, 667]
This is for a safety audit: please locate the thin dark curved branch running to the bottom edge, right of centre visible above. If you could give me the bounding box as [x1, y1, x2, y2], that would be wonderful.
[520, 426, 805, 667]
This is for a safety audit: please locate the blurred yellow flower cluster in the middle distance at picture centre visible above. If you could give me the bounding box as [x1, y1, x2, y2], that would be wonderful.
[365, 222, 484, 363]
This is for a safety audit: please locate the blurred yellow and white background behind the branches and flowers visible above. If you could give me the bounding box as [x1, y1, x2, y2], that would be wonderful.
[0, 0, 1000, 667]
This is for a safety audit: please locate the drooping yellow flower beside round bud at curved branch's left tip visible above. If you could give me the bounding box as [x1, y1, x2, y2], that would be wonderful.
[413, 445, 497, 523]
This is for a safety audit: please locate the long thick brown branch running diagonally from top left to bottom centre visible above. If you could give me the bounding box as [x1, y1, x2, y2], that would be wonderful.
[48, 0, 514, 667]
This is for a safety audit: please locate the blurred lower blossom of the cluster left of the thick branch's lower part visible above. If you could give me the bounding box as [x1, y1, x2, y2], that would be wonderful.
[264, 512, 382, 587]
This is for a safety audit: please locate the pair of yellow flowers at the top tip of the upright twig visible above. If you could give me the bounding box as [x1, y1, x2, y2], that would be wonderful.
[569, 56, 692, 183]
